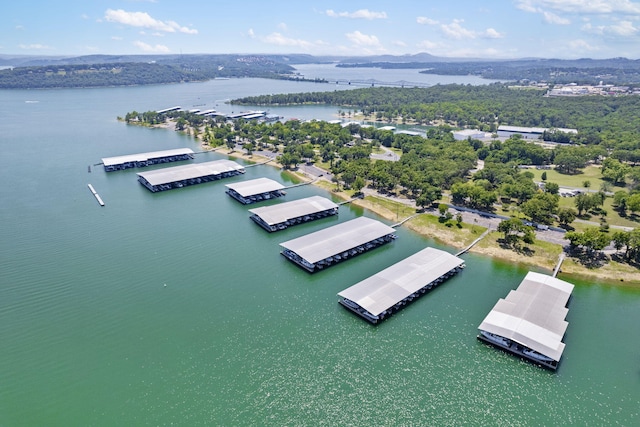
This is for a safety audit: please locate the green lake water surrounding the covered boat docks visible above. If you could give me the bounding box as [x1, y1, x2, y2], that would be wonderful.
[0, 75, 640, 426]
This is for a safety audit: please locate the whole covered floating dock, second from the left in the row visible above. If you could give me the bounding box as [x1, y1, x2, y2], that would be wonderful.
[138, 160, 245, 193]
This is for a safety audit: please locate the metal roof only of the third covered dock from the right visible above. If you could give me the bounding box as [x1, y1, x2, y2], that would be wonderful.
[280, 216, 395, 264]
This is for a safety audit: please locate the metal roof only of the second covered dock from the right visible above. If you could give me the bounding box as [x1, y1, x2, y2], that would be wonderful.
[338, 248, 464, 316]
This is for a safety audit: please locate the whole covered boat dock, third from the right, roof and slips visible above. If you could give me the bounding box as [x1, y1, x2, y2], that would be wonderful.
[280, 217, 396, 273]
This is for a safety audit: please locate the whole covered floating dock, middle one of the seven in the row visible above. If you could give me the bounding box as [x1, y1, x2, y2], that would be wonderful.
[249, 196, 338, 232]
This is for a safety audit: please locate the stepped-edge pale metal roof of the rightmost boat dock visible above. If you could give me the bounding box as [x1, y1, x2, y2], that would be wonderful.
[478, 272, 573, 362]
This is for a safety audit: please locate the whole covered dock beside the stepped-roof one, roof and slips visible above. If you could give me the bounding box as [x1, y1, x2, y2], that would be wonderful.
[338, 248, 464, 324]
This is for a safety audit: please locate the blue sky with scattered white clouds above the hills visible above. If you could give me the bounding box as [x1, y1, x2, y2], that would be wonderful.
[0, 0, 640, 59]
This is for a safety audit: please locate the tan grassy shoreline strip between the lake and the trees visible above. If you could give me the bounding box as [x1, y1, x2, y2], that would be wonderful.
[188, 133, 640, 289]
